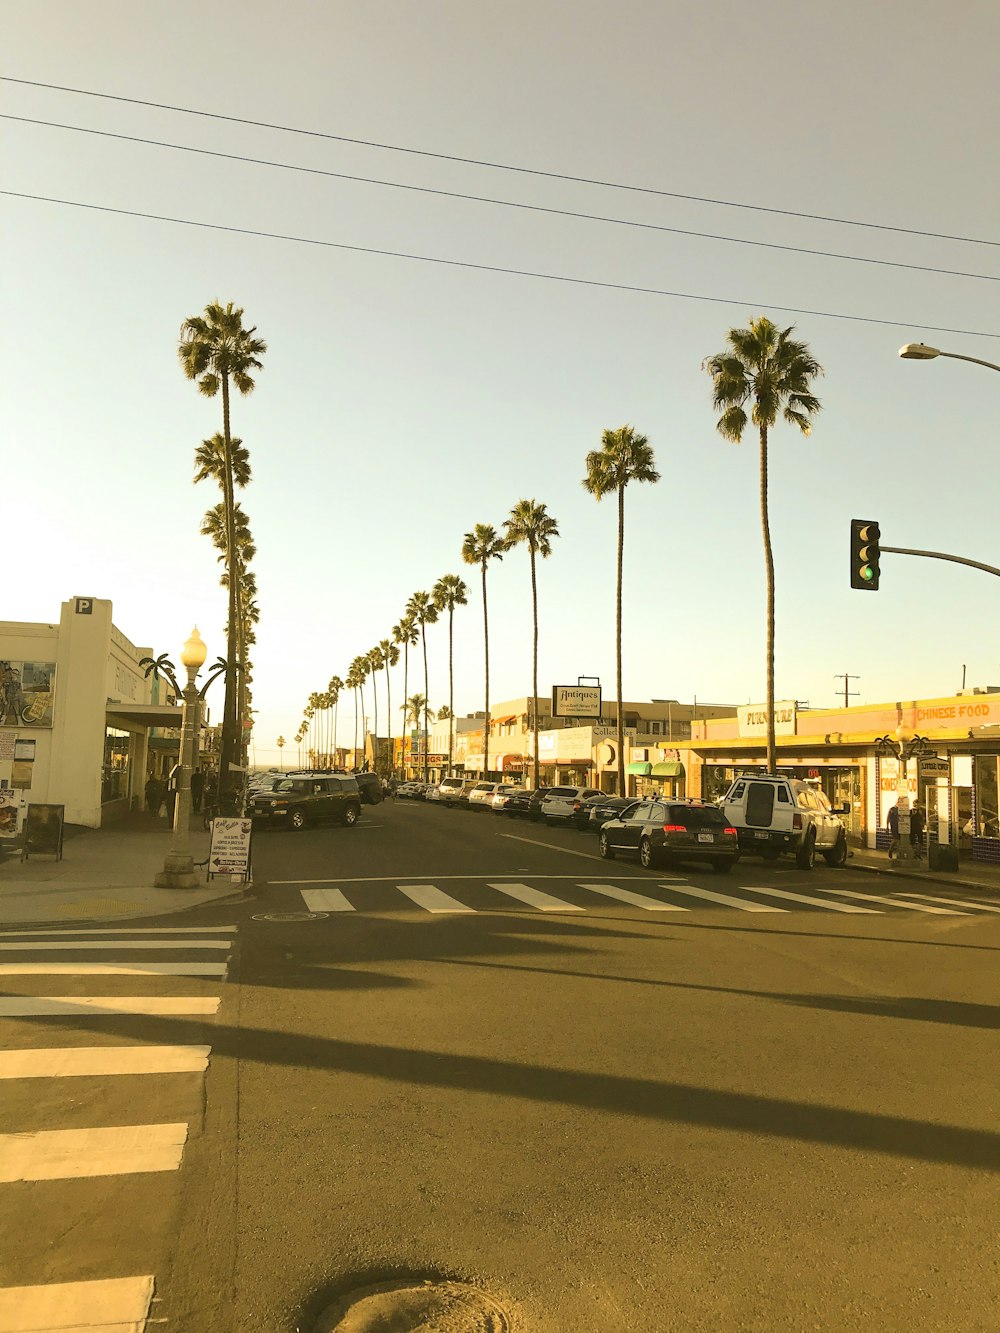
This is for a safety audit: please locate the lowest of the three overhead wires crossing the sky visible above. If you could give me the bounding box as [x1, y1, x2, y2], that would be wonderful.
[0, 189, 1000, 339]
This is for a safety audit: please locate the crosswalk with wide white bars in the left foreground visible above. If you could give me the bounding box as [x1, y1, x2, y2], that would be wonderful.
[0, 925, 236, 1333]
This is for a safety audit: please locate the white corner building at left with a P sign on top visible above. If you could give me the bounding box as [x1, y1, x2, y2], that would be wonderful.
[0, 597, 181, 828]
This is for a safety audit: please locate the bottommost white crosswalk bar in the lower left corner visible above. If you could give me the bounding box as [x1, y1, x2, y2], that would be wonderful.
[0, 1277, 153, 1333]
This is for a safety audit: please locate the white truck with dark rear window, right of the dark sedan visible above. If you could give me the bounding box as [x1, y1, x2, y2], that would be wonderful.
[719, 772, 848, 870]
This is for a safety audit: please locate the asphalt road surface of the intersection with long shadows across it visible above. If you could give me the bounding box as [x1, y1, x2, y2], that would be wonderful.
[0, 802, 1000, 1333]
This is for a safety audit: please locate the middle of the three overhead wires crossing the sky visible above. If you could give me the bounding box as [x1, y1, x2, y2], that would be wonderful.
[0, 112, 1000, 283]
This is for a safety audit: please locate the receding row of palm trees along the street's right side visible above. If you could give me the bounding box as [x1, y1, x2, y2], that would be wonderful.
[288, 316, 823, 794]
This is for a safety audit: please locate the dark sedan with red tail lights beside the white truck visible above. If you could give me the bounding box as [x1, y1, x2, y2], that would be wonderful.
[600, 797, 740, 873]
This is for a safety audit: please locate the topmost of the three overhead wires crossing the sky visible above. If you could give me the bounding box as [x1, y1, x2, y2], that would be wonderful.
[0, 75, 1000, 247]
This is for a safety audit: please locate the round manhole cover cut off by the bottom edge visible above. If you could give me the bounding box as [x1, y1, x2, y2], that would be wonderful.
[316, 1280, 511, 1333]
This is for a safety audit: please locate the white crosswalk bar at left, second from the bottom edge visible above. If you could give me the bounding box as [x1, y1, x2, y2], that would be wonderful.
[0, 1121, 188, 1181]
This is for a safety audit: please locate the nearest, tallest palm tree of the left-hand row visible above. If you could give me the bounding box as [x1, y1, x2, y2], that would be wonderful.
[177, 301, 267, 810]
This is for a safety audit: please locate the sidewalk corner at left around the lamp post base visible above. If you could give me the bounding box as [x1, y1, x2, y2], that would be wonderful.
[0, 814, 252, 928]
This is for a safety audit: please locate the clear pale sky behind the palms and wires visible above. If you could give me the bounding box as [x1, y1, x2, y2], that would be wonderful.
[0, 0, 1000, 762]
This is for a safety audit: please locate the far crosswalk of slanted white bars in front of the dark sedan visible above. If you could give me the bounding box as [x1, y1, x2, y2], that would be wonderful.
[300, 876, 1000, 917]
